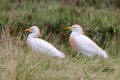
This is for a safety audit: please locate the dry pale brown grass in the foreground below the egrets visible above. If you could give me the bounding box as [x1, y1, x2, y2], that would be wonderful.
[0, 28, 120, 80]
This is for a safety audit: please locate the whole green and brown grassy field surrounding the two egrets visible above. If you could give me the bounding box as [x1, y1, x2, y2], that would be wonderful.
[0, 0, 120, 80]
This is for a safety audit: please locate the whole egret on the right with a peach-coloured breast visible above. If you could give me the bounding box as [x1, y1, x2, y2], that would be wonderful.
[65, 24, 108, 58]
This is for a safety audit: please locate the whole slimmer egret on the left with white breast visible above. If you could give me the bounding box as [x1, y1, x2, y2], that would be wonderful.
[24, 26, 65, 58]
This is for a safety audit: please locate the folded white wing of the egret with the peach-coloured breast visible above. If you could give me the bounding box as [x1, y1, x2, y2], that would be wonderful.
[76, 35, 100, 54]
